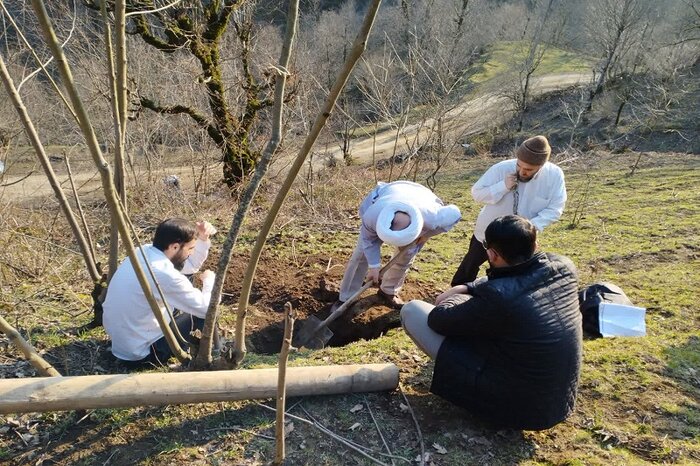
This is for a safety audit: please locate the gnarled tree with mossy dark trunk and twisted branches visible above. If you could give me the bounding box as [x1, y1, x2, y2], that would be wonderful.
[85, 0, 274, 186]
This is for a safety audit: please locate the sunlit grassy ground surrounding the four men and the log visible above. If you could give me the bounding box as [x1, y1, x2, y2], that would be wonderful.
[0, 153, 700, 465]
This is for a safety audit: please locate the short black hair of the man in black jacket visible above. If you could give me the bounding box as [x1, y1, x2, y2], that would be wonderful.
[485, 215, 537, 265]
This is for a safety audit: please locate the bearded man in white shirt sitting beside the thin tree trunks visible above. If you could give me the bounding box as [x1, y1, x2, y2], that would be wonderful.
[104, 218, 216, 368]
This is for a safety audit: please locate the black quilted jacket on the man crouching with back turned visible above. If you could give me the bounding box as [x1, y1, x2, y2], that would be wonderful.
[430, 253, 581, 429]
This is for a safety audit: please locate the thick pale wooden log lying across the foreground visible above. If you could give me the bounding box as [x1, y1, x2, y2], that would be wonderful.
[0, 364, 399, 414]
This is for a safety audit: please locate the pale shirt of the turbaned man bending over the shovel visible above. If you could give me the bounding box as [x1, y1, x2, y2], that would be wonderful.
[359, 180, 459, 268]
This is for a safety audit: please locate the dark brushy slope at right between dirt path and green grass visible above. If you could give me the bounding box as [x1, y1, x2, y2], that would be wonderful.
[493, 59, 700, 154]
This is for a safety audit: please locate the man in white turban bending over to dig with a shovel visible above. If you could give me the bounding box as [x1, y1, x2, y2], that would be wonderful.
[333, 181, 462, 309]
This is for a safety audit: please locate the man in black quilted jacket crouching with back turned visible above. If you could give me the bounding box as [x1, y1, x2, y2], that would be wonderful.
[401, 215, 581, 430]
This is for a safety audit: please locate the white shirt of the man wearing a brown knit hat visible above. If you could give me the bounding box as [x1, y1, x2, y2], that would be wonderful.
[472, 159, 566, 241]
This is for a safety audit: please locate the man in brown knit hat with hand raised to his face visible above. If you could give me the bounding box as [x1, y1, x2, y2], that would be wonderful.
[452, 136, 566, 286]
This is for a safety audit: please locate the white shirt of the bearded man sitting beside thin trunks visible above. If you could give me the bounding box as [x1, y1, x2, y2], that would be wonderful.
[103, 239, 214, 361]
